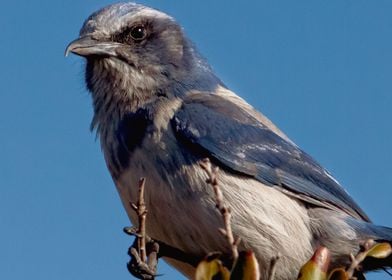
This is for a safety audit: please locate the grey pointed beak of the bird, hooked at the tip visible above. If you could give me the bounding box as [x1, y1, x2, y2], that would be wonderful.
[65, 36, 120, 57]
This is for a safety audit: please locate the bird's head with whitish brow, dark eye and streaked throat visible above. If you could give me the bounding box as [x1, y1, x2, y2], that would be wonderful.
[66, 3, 216, 104]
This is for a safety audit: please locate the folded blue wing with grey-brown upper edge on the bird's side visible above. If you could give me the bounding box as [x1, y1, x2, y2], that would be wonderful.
[172, 94, 369, 221]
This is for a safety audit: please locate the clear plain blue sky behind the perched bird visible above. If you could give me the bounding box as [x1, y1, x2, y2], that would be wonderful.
[0, 0, 392, 280]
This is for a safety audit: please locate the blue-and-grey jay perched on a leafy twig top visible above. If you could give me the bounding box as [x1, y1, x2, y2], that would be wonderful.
[66, 2, 392, 279]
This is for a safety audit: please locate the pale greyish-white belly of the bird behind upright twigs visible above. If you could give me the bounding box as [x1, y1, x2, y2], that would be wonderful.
[112, 140, 313, 279]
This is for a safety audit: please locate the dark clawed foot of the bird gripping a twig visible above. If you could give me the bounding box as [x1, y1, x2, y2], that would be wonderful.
[124, 227, 159, 280]
